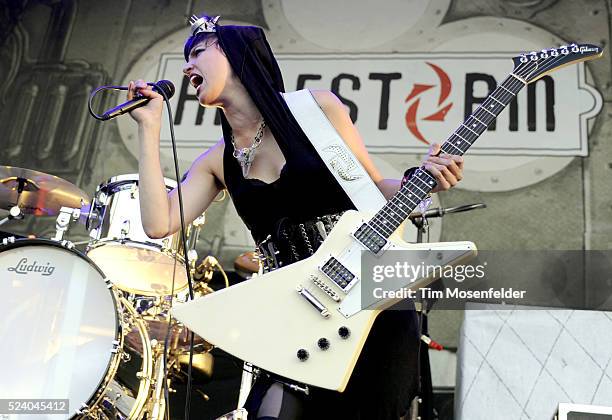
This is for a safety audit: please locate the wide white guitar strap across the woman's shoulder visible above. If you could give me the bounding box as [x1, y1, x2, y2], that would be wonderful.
[283, 89, 387, 212]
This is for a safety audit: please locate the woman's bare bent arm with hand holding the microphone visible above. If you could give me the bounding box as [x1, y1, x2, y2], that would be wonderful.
[128, 80, 223, 238]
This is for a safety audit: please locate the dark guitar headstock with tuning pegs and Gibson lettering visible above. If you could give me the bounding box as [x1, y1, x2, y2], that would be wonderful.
[512, 44, 603, 83]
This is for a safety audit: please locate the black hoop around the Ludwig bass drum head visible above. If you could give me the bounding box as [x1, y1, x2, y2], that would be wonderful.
[0, 238, 135, 418]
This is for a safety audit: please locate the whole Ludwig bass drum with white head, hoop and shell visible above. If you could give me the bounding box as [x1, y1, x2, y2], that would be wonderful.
[0, 239, 153, 420]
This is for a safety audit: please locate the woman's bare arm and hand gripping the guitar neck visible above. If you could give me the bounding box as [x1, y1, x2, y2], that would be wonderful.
[312, 90, 463, 200]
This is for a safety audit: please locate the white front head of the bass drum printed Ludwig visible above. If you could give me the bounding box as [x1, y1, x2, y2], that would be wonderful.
[0, 240, 119, 418]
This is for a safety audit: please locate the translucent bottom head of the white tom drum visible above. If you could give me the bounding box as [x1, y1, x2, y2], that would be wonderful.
[87, 241, 187, 296]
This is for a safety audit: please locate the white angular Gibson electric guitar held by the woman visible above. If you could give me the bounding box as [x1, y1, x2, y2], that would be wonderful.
[172, 44, 602, 392]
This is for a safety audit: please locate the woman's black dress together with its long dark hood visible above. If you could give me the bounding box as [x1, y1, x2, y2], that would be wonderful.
[210, 26, 436, 420]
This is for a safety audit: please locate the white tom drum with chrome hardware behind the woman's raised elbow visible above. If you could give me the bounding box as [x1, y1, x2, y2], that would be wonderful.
[86, 174, 201, 296]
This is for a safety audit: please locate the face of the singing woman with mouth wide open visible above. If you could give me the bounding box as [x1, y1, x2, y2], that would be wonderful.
[183, 36, 231, 106]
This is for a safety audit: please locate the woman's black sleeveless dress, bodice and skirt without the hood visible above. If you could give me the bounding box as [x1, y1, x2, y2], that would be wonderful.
[222, 118, 429, 420]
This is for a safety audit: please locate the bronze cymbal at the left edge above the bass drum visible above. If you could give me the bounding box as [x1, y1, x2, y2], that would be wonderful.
[0, 165, 89, 216]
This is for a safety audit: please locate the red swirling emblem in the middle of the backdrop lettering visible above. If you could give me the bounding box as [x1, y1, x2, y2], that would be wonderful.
[404, 62, 453, 144]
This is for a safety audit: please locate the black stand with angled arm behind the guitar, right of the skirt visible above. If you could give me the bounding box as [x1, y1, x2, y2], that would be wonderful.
[408, 203, 487, 420]
